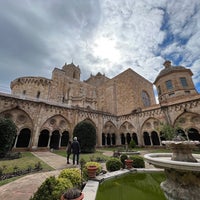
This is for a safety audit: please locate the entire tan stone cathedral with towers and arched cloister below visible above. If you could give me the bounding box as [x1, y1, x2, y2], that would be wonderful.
[0, 61, 200, 150]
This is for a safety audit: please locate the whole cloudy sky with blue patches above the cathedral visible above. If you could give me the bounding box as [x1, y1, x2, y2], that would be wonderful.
[0, 0, 200, 92]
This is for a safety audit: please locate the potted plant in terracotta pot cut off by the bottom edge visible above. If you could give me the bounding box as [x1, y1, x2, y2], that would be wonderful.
[60, 188, 84, 200]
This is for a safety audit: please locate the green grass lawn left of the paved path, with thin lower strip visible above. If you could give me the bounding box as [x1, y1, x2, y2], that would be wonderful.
[0, 152, 53, 186]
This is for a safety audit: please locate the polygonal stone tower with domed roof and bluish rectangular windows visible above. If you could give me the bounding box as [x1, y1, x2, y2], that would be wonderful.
[154, 60, 197, 103]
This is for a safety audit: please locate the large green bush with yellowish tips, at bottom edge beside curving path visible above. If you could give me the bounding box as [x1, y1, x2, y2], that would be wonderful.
[30, 176, 72, 200]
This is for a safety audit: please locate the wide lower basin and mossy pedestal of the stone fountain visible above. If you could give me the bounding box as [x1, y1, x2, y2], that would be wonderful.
[144, 153, 200, 200]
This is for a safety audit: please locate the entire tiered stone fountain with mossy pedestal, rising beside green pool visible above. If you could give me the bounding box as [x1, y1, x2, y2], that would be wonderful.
[144, 141, 200, 200]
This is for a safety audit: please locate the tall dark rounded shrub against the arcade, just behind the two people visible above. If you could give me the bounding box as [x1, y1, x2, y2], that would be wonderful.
[73, 121, 96, 153]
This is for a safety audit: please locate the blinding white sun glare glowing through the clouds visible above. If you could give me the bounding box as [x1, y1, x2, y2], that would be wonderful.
[94, 37, 120, 62]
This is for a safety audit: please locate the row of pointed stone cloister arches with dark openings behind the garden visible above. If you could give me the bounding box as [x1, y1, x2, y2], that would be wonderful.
[0, 105, 200, 149]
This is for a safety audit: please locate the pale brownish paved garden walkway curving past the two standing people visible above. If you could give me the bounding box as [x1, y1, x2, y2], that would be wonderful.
[0, 152, 153, 200]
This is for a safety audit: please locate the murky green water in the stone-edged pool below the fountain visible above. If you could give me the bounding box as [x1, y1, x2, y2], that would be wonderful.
[96, 172, 166, 200]
